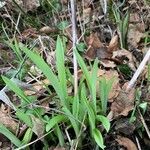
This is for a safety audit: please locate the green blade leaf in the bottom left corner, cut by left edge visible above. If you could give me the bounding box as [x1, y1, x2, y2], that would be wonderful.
[0, 123, 21, 147]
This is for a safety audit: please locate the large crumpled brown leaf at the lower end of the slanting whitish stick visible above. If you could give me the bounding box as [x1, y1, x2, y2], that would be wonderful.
[111, 83, 135, 118]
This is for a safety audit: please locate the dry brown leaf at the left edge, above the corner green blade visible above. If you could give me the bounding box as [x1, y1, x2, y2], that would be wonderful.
[0, 104, 18, 133]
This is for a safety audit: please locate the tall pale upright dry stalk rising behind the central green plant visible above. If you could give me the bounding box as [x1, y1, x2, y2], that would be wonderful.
[70, 0, 78, 95]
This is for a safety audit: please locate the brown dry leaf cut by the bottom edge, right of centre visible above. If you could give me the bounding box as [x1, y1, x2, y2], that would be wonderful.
[116, 136, 138, 150]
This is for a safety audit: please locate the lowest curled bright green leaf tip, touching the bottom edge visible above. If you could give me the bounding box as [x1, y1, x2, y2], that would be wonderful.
[92, 128, 105, 149]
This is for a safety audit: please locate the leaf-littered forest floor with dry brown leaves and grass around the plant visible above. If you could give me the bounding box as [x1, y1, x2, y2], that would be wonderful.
[0, 0, 150, 150]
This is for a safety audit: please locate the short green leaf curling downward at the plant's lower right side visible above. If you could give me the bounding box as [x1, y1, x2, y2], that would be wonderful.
[96, 115, 110, 132]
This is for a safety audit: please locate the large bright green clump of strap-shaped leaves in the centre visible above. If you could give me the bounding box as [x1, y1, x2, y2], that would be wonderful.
[2, 36, 113, 149]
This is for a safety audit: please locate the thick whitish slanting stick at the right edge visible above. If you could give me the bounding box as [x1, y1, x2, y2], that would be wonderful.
[127, 49, 150, 90]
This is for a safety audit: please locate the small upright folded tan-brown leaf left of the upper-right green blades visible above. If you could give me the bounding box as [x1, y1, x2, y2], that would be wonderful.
[108, 35, 118, 52]
